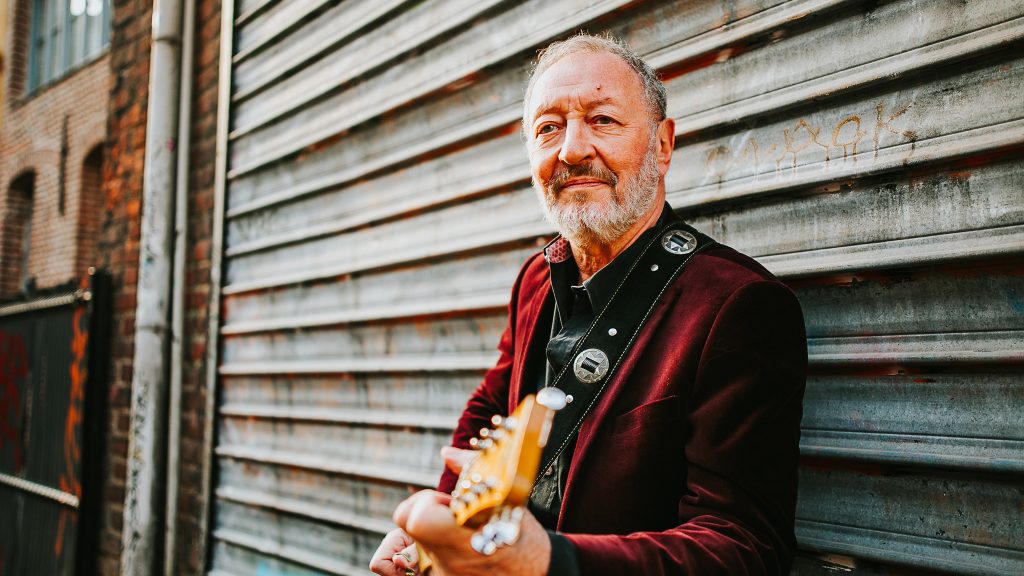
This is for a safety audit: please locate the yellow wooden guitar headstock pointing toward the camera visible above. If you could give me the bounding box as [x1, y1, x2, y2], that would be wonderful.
[451, 395, 554, 527]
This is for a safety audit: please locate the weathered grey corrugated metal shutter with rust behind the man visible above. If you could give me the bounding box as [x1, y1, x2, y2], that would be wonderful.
[213, 0, 1024, 574]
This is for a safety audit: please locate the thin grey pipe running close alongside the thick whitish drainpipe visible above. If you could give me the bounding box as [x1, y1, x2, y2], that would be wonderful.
[164, 0, 196, 576]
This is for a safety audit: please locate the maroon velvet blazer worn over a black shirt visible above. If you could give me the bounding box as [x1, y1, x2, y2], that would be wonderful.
[438, 241, 807, 576]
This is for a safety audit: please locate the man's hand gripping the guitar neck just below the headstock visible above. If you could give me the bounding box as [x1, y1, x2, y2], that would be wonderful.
[393, 490, 551, 576]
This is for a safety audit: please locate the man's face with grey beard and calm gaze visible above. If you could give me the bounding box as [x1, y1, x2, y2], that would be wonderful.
[525, 52, 674, 243]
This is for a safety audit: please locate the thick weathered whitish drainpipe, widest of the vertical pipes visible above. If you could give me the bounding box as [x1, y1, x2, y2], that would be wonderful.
[121, 0, 181, 576]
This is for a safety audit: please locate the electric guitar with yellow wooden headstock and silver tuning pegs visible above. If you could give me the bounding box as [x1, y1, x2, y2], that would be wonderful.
[417, 388, 565, 575]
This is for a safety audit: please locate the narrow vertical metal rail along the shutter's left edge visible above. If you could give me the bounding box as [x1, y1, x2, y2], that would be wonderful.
[197, 0, 234, 567]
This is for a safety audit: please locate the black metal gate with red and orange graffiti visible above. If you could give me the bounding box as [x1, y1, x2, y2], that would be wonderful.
[0, 271, 109, 576]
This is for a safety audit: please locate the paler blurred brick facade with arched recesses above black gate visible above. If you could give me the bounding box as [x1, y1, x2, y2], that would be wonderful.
[0, 0, 111, 298]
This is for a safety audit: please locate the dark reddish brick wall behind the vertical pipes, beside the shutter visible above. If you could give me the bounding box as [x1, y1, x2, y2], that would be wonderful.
[98, 0, 220, 574]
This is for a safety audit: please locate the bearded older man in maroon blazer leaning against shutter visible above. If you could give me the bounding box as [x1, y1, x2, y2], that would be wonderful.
[371, 35, 807, 576]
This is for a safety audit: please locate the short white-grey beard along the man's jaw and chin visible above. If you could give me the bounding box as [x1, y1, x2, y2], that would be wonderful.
[534, 137, 660, 246]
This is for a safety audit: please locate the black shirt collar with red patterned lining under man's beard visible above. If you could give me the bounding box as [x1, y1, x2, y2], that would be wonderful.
[544, 202, 679, 321]
